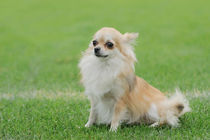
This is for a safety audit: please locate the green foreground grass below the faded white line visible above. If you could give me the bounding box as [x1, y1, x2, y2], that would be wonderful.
[0, 99, 210, 139]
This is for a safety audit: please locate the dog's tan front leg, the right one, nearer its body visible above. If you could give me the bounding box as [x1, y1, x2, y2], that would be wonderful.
[110, 100, 126, 131]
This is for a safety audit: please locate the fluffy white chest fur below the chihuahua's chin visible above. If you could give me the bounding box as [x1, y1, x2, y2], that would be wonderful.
[79, 56, 124, 97]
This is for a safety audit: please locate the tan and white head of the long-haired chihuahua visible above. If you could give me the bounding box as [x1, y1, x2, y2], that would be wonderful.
[89, 27, 138, 61]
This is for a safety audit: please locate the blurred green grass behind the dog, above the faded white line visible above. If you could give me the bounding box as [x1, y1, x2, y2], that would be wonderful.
[0, 0, 210, 93]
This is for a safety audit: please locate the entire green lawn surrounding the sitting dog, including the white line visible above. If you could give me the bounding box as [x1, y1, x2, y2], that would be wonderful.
[0, 0, 210, 140]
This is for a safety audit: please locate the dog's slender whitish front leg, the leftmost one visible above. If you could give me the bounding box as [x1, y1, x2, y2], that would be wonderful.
[85, 99, 97, 127]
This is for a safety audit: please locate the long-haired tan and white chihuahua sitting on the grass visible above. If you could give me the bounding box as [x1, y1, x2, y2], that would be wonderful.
[79, 27, 190, 131]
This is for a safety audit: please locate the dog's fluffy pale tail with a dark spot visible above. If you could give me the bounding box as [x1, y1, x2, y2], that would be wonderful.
[166, 89, 191, 126]
